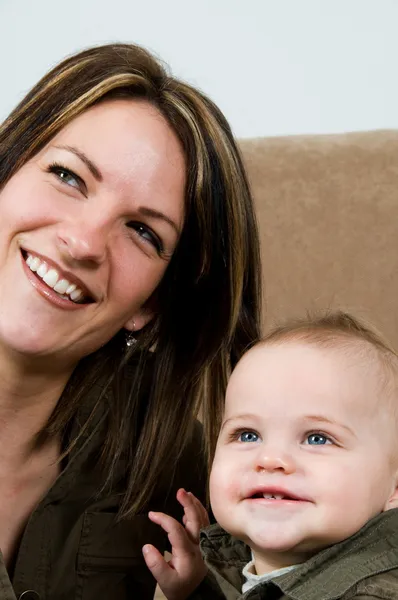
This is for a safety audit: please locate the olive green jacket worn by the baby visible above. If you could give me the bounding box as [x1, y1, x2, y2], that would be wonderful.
[191, 509, 398, 600]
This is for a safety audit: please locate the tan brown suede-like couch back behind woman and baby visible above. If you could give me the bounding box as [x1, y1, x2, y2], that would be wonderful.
[240, 131, 398, 348]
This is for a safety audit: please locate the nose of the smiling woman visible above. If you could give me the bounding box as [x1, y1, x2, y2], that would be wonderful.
[57, 221, 108, 264]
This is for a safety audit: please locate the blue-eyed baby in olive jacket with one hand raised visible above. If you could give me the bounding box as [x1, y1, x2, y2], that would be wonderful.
[144, 313, 398, 600]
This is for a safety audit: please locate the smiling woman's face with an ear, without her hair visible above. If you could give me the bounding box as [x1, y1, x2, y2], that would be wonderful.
[0, 100, 186, 364]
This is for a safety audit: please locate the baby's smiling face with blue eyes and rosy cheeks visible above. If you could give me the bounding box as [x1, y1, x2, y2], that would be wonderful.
[210, 342, 396, 573]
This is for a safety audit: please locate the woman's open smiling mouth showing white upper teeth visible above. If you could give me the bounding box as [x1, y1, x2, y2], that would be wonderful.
[22, 250, 94, 304]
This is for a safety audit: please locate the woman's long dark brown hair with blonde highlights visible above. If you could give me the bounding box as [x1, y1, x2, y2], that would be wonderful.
[0, 44, 261, 515]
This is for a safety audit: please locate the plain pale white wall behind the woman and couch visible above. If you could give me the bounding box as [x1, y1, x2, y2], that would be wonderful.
[0, 0, 398, 137]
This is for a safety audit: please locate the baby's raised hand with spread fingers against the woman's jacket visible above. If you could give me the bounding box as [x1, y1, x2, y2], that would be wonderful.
[142, 489, 209, 600]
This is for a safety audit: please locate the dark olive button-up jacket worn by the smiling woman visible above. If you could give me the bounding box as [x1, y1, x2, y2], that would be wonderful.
[0, 378, 206, 600]
